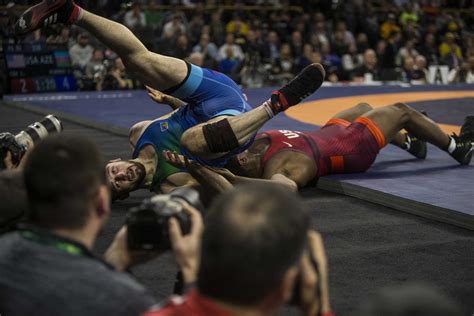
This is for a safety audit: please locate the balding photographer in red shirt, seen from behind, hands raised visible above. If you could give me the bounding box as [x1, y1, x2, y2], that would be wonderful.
[144, 185, 332, 316]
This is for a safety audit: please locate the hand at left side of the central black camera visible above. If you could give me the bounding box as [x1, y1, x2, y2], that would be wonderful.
[104, 226, 161, 271]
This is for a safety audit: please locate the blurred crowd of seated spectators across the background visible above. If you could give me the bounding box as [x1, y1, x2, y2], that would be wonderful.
[0, 0, 474, 90]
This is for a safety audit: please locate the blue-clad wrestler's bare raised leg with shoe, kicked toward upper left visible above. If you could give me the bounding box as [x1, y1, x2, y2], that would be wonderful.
[15, 0, 188, 91]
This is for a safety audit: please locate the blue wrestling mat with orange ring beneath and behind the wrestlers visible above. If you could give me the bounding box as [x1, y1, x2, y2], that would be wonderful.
[5, 85, 474, 229]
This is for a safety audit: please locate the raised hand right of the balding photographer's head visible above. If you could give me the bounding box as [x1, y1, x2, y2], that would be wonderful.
[300, 230, 331, 316]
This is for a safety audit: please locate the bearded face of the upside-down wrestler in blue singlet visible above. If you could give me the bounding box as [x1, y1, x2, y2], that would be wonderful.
[105, 159, 145, 199]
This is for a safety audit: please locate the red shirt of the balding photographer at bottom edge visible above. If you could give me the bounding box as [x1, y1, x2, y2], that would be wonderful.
[142, 289, 232, 316]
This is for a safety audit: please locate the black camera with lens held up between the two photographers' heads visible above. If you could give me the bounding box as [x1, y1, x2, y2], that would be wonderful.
[126, 188, 202, 251]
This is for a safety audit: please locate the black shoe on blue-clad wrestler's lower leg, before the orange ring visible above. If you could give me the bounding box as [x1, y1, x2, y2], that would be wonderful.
[270, 63, 326, 114]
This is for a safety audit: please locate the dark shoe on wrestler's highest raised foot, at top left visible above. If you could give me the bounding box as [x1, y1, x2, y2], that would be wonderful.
[14, 0, 81, 35]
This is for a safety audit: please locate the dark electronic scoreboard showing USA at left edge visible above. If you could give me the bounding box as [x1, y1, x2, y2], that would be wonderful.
[3, 43, 76, 94]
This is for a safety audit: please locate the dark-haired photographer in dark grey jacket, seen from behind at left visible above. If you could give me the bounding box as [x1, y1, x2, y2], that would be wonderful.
[0, 135, 159, 315]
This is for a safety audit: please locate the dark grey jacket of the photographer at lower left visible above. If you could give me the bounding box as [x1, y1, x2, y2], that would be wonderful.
[0, 230, 156, 316]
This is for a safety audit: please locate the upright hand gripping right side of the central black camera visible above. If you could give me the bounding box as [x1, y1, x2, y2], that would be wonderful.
[169, 205, 204, 284]
